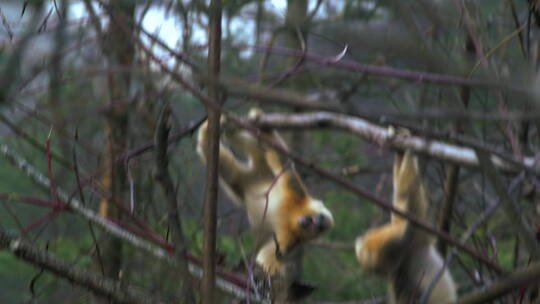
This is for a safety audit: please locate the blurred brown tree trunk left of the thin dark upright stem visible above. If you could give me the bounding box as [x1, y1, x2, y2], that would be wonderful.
[99, 0, 135, 279]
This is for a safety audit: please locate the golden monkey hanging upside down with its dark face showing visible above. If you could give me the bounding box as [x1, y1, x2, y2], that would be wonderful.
[197, 109, 334, 275]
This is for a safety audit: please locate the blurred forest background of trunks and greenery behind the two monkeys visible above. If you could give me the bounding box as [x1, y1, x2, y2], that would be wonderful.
[0, 0, 540, 303]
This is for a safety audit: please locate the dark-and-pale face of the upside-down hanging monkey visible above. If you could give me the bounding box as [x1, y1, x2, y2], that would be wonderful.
[293, 198, 334, 239]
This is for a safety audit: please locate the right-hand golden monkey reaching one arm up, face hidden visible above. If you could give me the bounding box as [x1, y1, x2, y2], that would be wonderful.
[355, 150, 457, 304]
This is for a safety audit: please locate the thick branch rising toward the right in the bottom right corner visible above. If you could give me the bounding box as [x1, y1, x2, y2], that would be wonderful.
[458, 263, 540, 304]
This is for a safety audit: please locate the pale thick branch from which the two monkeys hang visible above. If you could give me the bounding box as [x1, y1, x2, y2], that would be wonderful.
[256, 112, 540, 174]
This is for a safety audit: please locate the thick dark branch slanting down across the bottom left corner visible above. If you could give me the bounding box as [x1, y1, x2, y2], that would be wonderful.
[0, 230, 164, 304]
